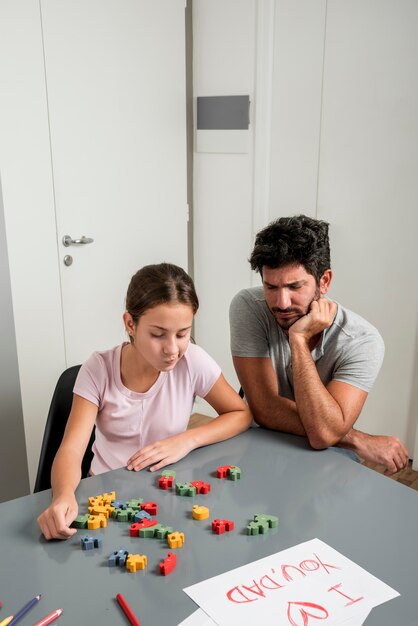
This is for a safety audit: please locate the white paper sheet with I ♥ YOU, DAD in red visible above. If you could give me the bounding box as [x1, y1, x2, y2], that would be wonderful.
[184, 539, 399, 626]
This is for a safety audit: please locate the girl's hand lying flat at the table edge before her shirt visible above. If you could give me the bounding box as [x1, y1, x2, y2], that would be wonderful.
[127, 432, 194, 472]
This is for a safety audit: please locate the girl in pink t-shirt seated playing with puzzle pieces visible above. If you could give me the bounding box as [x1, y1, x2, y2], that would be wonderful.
[38, 263, 251, 539]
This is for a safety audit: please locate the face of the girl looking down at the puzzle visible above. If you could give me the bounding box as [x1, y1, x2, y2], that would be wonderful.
[124, 302, 193, 372]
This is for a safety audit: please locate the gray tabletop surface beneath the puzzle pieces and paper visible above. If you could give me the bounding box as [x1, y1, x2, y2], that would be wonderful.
[0, 429, 418, 626]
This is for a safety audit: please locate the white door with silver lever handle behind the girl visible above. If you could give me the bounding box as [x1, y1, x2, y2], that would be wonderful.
[40, 0, 187, 365]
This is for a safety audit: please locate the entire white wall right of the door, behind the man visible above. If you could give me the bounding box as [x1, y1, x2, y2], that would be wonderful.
[194, 0, 418, 457]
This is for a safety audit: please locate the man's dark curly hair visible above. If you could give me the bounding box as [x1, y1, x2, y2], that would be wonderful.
[249, 215, 331, 284]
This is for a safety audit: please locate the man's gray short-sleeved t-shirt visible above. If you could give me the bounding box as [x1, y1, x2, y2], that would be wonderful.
[229, 287, 385, 400]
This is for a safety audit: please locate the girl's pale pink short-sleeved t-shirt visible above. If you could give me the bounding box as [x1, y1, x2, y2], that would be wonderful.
[74, 343, 221, 474]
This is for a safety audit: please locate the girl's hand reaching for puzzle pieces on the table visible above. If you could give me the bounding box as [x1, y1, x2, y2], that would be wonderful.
[38, 494, 78, 539]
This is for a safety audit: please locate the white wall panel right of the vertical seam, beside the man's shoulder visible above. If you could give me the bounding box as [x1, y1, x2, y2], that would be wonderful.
[318, 0, 418, 460]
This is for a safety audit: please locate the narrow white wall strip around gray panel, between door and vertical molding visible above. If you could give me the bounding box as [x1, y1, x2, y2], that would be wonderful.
[193, 0, 256, 410]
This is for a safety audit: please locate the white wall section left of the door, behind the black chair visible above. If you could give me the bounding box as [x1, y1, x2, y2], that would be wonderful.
[0, 0, 65, 490]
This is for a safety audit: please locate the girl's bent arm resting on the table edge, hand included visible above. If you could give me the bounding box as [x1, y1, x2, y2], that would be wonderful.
[127, 374, 252, 472]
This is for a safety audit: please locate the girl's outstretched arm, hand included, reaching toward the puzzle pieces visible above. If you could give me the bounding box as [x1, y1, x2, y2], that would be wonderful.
[38, 394, 97, 539]
